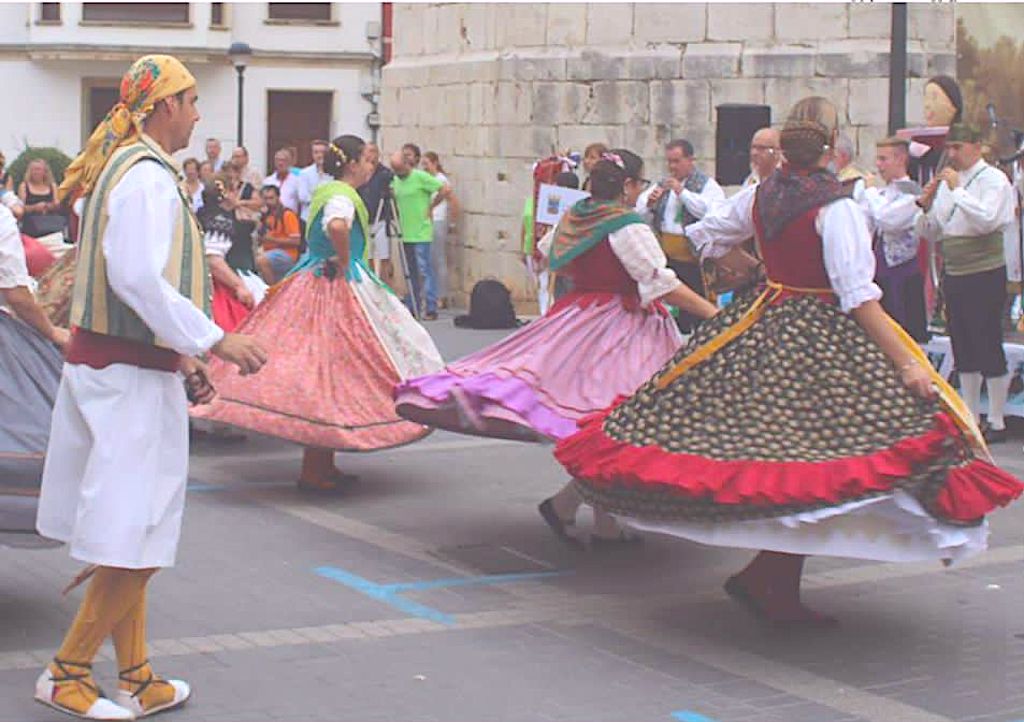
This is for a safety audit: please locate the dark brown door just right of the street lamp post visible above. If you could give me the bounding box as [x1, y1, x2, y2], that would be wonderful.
[266, 90, 334, 173]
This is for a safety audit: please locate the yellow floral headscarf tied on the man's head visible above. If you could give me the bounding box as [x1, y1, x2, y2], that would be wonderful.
[57, 55, 196, 200]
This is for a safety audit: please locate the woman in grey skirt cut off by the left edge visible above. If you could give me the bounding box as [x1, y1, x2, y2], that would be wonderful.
[0, 199, 70, 455]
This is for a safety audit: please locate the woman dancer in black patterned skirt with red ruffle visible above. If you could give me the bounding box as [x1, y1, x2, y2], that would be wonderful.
[556, 97, 1022, 625]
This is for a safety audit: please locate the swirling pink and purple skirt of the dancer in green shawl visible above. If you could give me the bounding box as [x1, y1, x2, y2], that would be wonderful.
[394, 294, 681, 441]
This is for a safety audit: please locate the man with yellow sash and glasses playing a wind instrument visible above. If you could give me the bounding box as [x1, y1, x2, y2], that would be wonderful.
[636, 139, 725, 333]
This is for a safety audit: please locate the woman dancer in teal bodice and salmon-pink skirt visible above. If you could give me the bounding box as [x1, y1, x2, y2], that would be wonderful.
[193, 135, 442, 492]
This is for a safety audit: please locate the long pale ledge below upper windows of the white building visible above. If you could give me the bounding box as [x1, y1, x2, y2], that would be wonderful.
[0, 43, 374, 67]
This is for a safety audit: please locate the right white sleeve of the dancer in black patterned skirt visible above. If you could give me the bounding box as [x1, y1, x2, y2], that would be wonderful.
[818, 199, 882, 312]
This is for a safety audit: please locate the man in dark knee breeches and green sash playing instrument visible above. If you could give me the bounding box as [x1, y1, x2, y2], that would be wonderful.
[916, 123, 1013, 441]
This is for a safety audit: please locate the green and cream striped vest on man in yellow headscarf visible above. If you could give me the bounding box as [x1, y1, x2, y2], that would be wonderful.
[71, 136, 211, 346]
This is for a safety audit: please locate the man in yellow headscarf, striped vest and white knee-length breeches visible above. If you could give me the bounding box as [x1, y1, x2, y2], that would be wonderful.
[36, 55, 266, 720]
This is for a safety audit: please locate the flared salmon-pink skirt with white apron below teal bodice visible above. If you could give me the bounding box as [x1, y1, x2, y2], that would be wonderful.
[193, 271, 442, 452]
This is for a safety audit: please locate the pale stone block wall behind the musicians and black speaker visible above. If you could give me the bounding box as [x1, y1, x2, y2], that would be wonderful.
[381, 3, 955, 310]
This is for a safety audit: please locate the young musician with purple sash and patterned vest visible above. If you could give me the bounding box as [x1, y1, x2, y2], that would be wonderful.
[855, 136, 928, 342]
